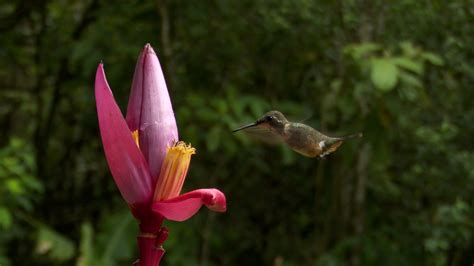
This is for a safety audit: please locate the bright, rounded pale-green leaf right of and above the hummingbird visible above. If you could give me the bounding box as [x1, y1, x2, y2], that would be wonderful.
[370, 58, 398, 92]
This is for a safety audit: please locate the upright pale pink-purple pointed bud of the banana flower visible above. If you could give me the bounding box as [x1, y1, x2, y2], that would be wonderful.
[126, 44, 178, 183]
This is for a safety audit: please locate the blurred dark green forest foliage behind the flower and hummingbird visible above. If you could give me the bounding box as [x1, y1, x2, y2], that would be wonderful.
[0, 0, 474, 266]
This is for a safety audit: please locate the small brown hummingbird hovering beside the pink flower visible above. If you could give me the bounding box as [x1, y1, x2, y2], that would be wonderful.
[232, 111, 362, 158]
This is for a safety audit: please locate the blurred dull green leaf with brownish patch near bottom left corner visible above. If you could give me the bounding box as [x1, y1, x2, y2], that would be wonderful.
[36, 226, 75, 261]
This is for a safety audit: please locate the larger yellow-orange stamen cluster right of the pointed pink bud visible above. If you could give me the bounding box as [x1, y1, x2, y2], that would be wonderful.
[153, 141, 196, 201]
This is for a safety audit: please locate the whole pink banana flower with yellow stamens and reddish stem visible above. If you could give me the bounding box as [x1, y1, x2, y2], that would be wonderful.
[95, 44, 226, 266]
